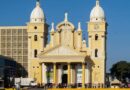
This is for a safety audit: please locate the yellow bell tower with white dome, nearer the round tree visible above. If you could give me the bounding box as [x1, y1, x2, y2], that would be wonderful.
[88, 0, 107, 84]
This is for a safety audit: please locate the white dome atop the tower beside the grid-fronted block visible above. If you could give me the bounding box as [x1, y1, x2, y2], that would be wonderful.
[30, 0, 45, 23]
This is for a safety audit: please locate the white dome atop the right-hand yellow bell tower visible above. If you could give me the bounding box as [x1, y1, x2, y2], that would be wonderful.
[90, 0, 105, 22]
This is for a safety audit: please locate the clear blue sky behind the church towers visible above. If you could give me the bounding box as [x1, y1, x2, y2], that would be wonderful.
[0, 0, 130, 71]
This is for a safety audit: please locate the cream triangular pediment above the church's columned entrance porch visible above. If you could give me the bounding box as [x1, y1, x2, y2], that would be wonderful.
[40, 46, 81, 56]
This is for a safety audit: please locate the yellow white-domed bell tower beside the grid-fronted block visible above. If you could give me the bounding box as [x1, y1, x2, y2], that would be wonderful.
[27, 0, 48, 83]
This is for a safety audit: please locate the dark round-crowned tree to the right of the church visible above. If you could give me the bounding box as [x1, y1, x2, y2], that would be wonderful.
[110, 61, 130, 82]
